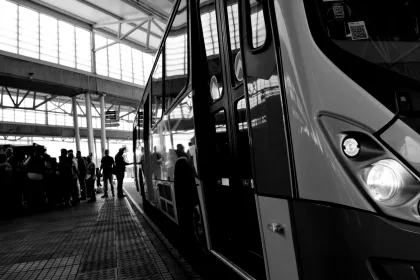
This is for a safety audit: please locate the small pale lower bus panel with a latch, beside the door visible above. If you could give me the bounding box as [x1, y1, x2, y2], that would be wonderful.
[257, 196, 299, 280]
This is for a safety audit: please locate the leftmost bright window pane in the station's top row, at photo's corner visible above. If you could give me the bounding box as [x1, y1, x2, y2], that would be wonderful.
[0, 0, 18, 53]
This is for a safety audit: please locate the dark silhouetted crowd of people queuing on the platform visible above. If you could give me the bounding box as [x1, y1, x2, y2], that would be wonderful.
[0, 146, 131, 219]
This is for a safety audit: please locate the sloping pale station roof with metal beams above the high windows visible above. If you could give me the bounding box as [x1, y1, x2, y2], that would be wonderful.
[30, 0, 174, 53]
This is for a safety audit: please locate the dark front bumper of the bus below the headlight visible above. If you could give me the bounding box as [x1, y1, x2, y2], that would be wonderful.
[293, 201, 420, 280]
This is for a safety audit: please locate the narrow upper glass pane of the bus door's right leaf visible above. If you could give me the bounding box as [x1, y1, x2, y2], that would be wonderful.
[227, 0, 241, 86]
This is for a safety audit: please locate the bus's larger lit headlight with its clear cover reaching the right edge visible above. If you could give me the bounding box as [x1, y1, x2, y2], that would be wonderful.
[364, 159, 420, 207]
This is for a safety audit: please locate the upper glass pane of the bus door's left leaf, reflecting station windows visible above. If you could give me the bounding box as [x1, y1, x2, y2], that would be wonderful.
[200, 0, 223, 100]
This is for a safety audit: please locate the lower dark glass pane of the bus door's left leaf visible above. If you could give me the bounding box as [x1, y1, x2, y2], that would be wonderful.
[213, 110, 231, 177]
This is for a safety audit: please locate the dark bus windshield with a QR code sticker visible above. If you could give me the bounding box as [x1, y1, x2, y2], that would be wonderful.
[315, 0, 420, 84]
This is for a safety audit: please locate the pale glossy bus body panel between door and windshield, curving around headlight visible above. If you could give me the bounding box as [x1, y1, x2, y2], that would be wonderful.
[274, 0, 393, 211]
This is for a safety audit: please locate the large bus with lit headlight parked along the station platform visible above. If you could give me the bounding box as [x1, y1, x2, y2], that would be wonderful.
[133, 0, 420, 280]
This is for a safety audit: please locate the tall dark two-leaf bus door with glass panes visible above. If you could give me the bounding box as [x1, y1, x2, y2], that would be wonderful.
[196, 0, 265, 279]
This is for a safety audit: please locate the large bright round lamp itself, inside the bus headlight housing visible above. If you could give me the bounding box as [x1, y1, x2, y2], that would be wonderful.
[366, 160, 402, 202]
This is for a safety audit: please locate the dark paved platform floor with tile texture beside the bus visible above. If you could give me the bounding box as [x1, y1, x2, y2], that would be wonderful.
[0, 195, 200, 280]
